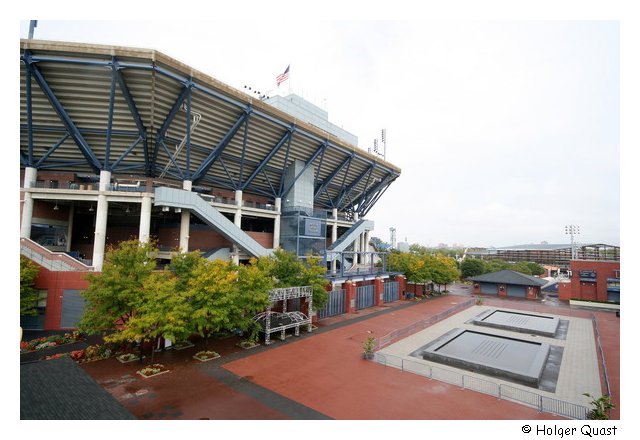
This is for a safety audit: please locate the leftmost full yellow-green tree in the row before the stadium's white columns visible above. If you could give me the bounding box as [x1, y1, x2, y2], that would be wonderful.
[79, 240, 155, 334]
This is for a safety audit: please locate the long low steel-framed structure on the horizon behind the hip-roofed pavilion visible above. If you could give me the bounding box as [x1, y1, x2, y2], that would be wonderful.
[467, 243, 620, 270]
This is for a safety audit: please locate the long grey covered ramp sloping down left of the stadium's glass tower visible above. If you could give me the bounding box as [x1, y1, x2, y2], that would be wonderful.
[153, 187, 273, 257]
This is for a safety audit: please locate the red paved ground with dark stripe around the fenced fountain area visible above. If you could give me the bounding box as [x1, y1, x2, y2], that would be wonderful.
[71, 295, 620, 420]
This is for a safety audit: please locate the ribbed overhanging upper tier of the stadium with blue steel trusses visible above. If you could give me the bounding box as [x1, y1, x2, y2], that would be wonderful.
[20, 40, 400, 215]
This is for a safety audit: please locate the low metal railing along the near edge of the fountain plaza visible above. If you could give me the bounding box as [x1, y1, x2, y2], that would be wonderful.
[375, 353, 589, 420]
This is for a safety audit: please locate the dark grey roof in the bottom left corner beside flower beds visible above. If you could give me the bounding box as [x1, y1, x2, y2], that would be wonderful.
[20, 357, 135, 420]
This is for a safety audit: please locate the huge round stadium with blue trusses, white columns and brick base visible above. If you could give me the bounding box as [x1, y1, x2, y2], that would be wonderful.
[20, 40, 403, 329]
